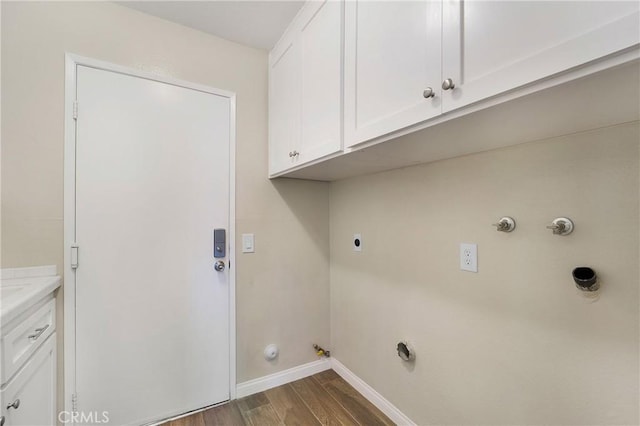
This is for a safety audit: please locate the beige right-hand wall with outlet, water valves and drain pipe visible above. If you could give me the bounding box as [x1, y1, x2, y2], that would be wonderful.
[330, 122, 640, 425]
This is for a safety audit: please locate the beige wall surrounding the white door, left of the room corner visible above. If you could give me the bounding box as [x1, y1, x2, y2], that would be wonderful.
[2, 2, 329, 412]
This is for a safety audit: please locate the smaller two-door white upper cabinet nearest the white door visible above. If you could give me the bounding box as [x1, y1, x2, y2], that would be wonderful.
[269, 1, 344, 175]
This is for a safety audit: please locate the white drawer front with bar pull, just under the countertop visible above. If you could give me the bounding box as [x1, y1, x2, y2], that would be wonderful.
[0, 299, 56, 383]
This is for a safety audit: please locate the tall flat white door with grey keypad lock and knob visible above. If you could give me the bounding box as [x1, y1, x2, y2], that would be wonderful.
[75, 66, 231, 425]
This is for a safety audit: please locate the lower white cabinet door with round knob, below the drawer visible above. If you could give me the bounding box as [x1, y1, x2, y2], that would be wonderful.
[0, 333, 56, 426]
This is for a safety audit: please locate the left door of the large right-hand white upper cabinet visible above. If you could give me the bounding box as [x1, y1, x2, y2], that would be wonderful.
[345, 0, 442, 146]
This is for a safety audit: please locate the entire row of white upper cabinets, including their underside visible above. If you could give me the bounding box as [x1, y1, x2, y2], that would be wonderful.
[269, 0, 640, 179]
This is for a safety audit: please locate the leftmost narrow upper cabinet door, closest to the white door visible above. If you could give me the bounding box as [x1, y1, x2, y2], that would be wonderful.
[269, 39, 300, 174]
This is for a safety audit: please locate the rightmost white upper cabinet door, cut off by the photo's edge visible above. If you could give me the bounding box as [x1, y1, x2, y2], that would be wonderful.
[442, 0, 640, 112]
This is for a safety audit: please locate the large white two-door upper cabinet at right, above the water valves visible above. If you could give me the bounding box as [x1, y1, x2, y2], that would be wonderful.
[344, 0, 640, 147]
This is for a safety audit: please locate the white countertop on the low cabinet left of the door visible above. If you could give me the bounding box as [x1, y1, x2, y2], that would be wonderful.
[0, 267, 61, 324]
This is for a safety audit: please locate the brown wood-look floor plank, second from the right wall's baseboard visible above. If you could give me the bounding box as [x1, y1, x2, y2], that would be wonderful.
[291, 377, 358, 426]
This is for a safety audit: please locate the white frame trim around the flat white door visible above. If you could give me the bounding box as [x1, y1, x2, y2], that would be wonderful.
[63, 53, 236, 420]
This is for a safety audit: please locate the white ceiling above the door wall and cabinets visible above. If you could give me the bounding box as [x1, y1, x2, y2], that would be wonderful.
[116, 0, 304, 50]
